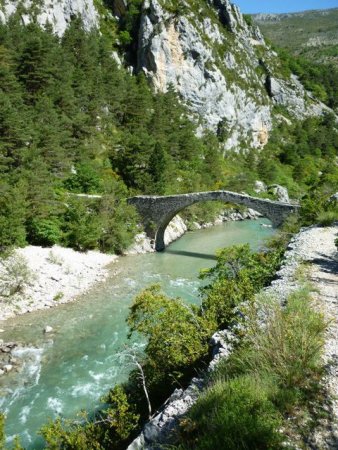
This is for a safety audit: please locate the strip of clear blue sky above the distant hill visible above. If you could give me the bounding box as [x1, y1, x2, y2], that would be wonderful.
[232, 0, 338, 14]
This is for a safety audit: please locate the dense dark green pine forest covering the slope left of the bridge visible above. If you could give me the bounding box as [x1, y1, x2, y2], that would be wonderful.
[0, 16, 226, 253]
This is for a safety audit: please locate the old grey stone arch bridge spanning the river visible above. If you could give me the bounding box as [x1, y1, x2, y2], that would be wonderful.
[128, 191, 299, 251]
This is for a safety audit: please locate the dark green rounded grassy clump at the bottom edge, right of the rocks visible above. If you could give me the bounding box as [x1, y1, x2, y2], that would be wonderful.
[181, 376, 282, 450]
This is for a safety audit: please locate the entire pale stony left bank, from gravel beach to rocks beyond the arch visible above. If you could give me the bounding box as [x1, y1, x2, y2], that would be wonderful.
[0, 209, 261, 321]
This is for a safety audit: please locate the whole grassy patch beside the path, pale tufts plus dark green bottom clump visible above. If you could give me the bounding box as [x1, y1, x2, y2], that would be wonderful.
[178, 288, 327, 450]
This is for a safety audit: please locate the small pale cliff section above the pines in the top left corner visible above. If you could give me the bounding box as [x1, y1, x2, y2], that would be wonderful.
[0, 0, 98, 36]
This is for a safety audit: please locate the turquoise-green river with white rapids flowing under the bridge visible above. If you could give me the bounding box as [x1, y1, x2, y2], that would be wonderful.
[0, 219, 274, 449]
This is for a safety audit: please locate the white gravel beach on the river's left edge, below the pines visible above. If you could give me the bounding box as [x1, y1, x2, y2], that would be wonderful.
[0, 246, 117, 320]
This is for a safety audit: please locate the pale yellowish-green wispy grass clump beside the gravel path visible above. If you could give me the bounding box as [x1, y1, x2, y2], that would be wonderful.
[216, 288, 327, 408]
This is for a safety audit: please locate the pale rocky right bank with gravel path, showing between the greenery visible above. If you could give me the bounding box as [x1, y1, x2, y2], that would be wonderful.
[128, 224, 338, 450]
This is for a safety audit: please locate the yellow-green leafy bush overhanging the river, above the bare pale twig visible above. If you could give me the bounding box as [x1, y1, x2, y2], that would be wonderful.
[128, 285, 209, 385]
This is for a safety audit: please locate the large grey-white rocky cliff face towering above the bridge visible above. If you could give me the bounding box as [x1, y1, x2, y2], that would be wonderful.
[137, 0, 323, 149]
